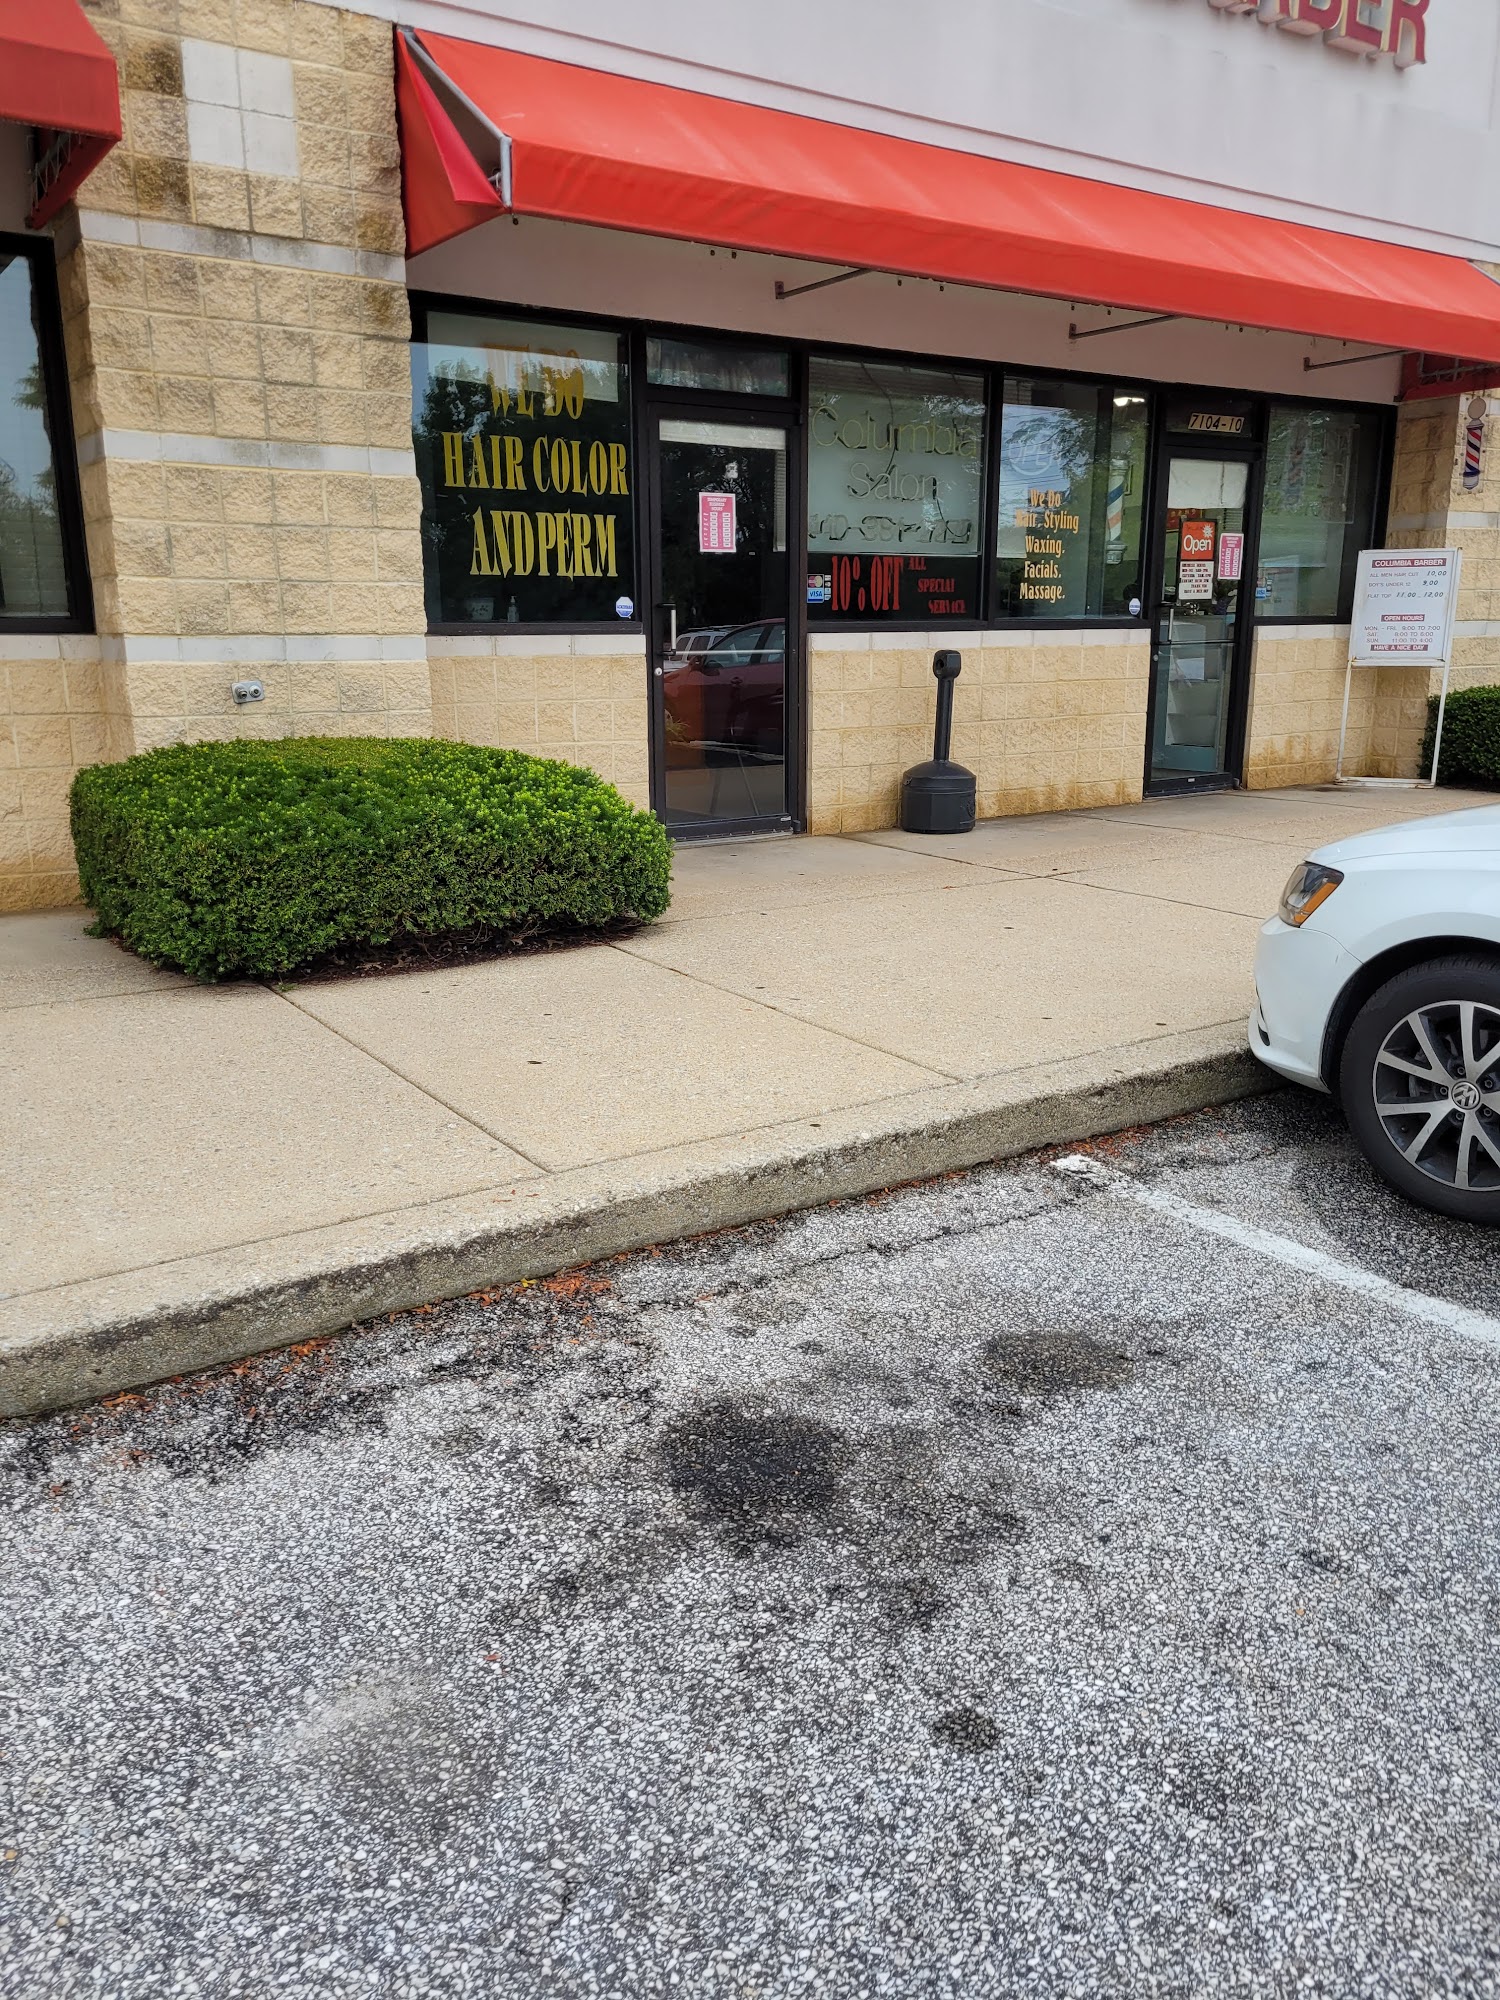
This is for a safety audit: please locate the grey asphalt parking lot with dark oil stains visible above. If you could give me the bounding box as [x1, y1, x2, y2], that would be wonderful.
[0, 1094, 1500, 2000]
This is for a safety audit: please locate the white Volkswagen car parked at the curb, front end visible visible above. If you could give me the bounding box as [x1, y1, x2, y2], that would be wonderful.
[1250, 806, 1500, 1222]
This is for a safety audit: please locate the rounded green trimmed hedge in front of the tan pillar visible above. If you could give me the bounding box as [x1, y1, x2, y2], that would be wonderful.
[72, 736, 672, 980]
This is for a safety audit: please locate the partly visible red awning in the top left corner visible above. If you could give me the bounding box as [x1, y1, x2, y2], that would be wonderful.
[0, 0, 120, 230]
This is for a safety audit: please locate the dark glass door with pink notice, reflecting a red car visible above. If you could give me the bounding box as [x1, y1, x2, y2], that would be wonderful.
[652, 410, 796, 836]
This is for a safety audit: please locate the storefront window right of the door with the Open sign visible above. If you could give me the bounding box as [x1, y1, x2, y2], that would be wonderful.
[1256, 402, 1384, 620]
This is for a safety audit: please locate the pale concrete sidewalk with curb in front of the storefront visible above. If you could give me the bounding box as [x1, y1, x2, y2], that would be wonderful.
[0, 790, 1492, 1414]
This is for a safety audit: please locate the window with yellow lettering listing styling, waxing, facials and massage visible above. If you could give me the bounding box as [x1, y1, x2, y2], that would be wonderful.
[994, 376, 1148, 620]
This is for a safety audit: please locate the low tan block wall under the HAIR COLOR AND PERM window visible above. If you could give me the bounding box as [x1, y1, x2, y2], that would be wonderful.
[430, 632, 650, 806]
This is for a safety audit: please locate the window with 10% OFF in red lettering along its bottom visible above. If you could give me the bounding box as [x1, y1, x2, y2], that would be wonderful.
[808, 356, 984, 624]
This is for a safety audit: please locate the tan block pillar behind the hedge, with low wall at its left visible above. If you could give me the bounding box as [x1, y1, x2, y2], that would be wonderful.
[0, 0, 430, 906]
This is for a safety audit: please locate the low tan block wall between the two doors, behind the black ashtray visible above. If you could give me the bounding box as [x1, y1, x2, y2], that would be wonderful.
[808, 632, 1150, 834]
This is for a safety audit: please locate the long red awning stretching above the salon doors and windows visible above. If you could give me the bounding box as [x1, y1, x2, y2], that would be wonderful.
[406, 32, 1500, 364]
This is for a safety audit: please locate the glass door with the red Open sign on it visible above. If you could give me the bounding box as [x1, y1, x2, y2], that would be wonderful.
[1148, 448, 1254, 792]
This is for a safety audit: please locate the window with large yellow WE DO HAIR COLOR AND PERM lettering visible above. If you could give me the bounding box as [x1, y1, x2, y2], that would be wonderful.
[412, 312, 638, 626]
